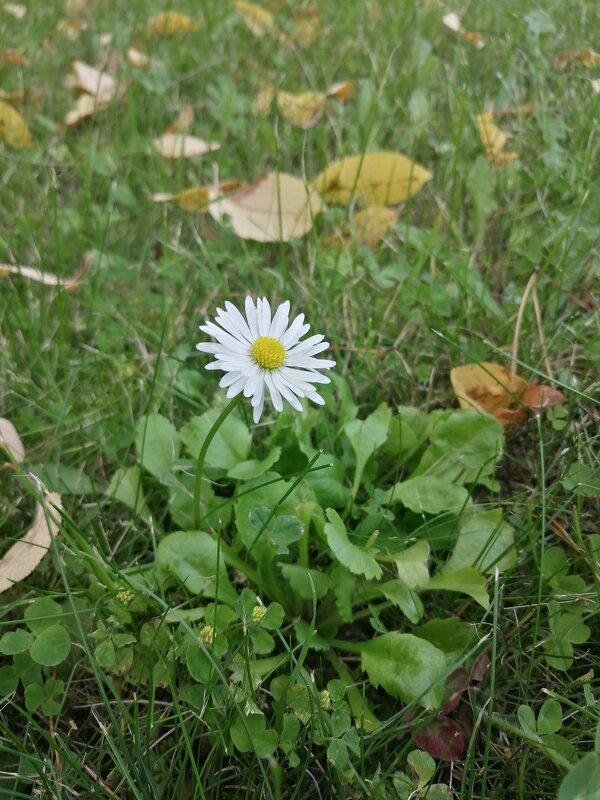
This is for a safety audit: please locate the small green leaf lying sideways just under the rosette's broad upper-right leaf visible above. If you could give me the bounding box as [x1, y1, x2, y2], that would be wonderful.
[380, 475, 469, 514]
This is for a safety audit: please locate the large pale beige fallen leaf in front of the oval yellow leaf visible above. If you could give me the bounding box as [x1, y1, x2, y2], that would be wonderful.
[208, 172, 322, 242]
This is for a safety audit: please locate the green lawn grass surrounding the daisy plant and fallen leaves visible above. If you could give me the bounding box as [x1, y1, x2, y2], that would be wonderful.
[0, 0, 600, 800]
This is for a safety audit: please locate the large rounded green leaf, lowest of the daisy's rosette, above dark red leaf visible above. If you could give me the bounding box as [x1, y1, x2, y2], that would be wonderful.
[361, 632, 447, 708]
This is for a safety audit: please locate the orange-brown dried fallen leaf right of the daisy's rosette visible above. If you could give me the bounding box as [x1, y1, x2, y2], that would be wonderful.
[450, 361, 565, 427]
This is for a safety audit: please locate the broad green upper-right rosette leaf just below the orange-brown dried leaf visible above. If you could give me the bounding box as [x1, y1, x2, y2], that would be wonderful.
[413, 410, 504, 484]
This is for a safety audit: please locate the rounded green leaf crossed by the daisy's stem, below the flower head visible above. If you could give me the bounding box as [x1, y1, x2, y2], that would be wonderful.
[181, 408, 252, 472]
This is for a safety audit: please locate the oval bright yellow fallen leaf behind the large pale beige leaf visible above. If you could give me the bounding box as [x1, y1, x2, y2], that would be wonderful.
[313, 153, 433, 206]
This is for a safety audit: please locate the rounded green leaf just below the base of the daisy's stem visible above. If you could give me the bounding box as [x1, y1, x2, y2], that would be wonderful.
[156, 531, 237, 604]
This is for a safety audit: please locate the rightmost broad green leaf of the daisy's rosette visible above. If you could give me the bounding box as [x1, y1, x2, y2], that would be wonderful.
[443, 508, 516, 575]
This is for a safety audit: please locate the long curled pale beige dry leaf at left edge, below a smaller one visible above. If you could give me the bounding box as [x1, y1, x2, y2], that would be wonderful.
[0, 492, 62, 592]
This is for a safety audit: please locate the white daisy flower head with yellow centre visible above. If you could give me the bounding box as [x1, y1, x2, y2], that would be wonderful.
[196, 297, 335, 422]
